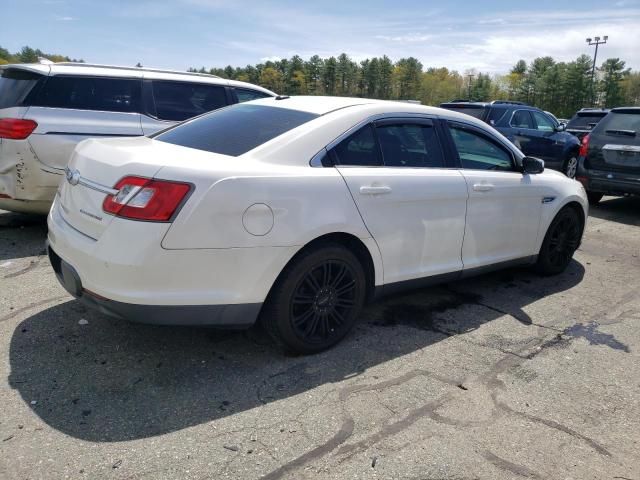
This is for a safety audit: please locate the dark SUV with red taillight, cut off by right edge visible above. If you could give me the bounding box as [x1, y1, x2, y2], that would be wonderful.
[576, 107, 640, 204]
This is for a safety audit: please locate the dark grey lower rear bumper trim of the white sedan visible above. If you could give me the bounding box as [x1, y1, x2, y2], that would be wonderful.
[47, 245, 262, 328]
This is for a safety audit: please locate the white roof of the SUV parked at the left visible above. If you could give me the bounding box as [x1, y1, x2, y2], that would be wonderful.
[0, 62, 276, 96]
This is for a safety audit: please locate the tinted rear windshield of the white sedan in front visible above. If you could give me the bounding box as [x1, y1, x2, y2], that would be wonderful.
[154, 103, 318, 157]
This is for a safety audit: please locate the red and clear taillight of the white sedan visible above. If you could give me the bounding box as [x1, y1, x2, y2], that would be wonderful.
[102, 177, 191, 222]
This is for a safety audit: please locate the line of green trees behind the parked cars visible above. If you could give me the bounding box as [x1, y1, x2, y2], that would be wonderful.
[0, 46, 640, 118]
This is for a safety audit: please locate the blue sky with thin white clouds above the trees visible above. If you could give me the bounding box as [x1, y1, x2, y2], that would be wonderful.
[0, 0, 640, 73]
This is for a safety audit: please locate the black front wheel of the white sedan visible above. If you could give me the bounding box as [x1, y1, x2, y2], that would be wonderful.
[535, 207, 584, 275]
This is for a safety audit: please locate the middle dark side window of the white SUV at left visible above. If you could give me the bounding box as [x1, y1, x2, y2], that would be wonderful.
[152, 80, 227, 122]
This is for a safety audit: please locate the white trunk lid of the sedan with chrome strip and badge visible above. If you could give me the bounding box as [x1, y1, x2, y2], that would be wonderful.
[58, 137, 176, 240]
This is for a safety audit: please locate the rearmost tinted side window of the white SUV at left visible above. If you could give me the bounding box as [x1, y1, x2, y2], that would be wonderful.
[33, 75, 141, 112]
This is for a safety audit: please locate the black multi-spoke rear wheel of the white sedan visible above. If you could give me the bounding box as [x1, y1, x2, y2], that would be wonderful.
[261, 243, 367, 354]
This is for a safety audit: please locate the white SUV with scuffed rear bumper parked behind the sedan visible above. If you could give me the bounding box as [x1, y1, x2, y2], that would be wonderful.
[0, 63, 275, 213]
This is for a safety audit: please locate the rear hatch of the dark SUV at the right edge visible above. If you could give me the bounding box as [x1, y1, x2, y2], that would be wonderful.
[585, 107, 640, 173]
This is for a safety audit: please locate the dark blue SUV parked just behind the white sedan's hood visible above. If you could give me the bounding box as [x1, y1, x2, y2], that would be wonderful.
[440, 100, 580, 178]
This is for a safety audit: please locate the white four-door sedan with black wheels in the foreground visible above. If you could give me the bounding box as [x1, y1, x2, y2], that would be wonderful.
[48, 97, 588, 353]
